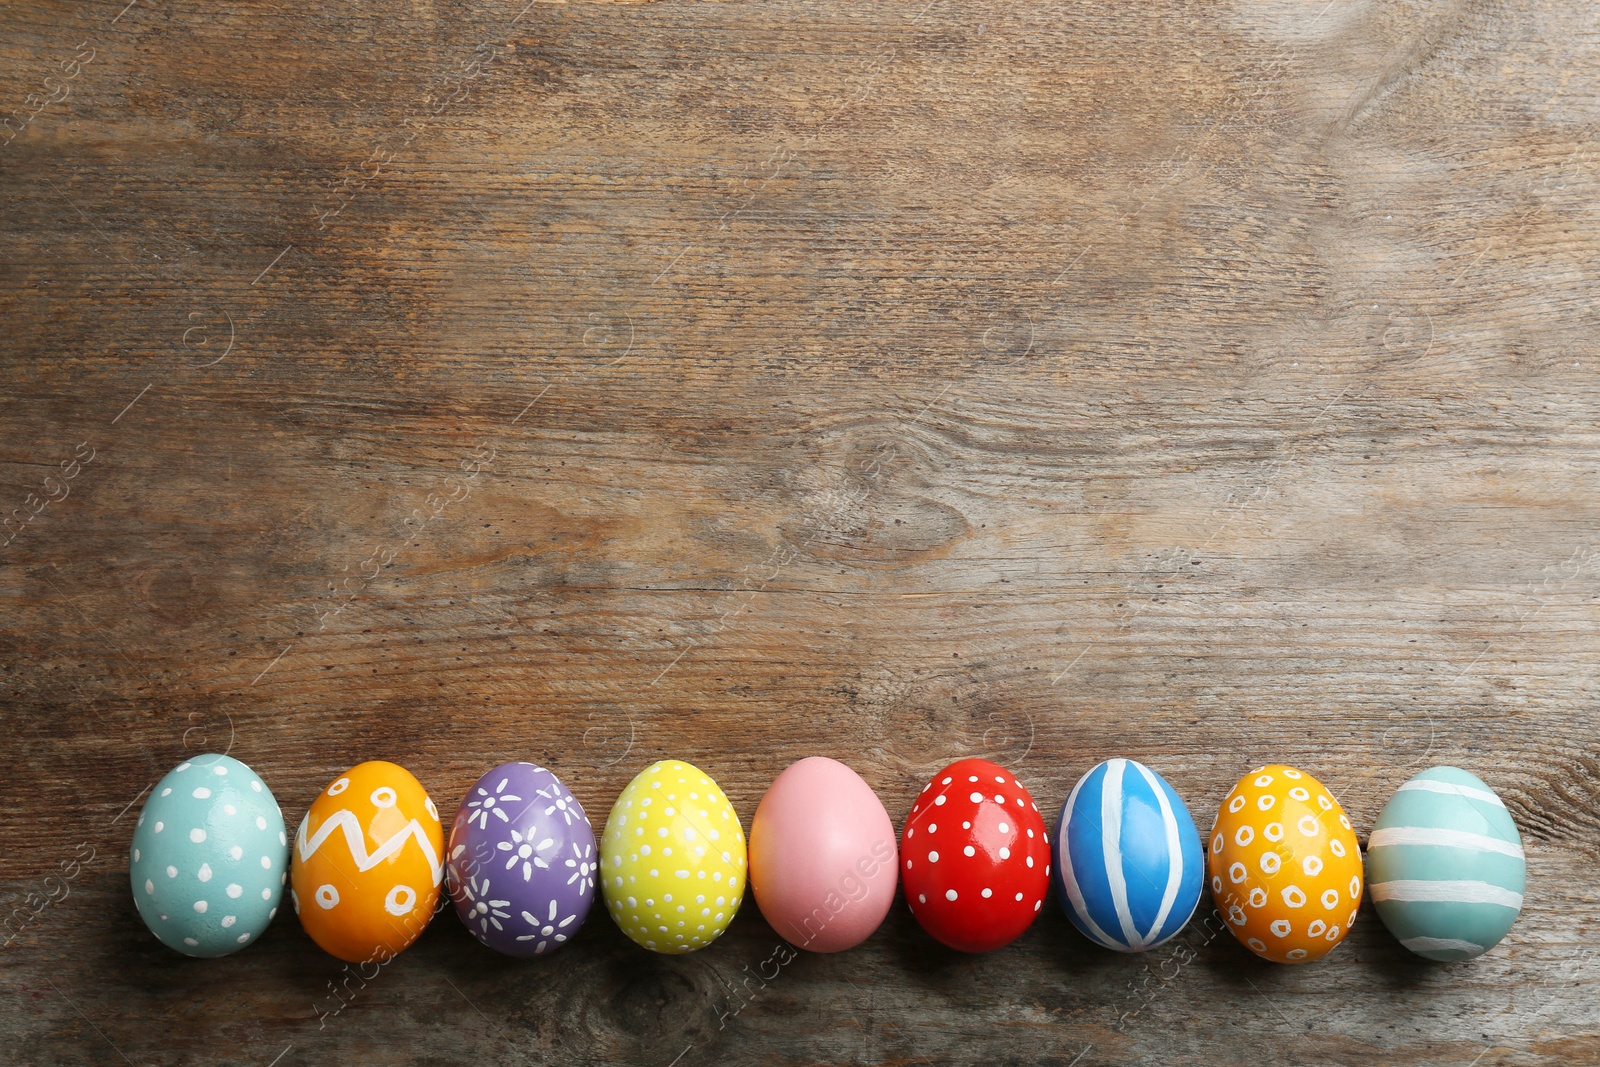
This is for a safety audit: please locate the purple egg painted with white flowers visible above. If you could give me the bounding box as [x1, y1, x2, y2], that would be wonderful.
[445, 763, 600, 957]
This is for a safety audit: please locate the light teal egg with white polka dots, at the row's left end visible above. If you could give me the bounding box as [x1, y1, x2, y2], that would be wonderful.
[128, 753, 290, 957]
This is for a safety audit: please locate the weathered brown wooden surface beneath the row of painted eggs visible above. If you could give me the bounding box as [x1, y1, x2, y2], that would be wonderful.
[0, 0, 1600, 1067]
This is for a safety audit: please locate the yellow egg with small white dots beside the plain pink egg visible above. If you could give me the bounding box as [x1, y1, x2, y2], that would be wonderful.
[600, 760, 746, 953]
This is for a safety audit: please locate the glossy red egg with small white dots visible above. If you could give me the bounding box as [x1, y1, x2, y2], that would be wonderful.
[901, 760, 1050, 952]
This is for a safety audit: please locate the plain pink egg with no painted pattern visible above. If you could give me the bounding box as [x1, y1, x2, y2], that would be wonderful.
[750, 755, 898, 952]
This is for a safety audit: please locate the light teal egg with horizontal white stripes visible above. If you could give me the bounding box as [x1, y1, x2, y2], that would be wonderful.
[1366, 766, 1528, 961]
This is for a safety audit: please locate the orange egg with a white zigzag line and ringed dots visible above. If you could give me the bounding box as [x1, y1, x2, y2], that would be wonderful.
[290, 760, 445, 963]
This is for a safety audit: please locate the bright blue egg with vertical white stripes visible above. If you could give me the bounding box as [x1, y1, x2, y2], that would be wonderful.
[1054, 760, 1205, 952]
